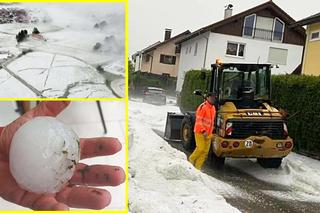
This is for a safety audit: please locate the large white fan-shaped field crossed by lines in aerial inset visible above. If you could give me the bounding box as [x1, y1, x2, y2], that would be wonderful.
[7, 52, 114, 97]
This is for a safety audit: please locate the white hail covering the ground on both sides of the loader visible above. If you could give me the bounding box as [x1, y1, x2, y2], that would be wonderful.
[129, 99, 320, 213]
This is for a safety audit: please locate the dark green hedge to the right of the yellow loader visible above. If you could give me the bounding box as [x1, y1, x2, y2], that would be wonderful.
[272, 75, 320, 157]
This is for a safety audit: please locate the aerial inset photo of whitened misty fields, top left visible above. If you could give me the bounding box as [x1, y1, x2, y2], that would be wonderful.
[0, 3, 125, 98]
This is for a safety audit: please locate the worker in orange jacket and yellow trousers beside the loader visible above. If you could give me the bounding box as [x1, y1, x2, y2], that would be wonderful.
[189, 93, 216, 170]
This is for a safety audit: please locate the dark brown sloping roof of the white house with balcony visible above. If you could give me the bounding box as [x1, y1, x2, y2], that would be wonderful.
[176, 0, 305, 44]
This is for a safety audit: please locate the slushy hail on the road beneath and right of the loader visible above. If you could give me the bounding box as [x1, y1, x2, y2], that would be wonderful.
[226, 152, 320, 202]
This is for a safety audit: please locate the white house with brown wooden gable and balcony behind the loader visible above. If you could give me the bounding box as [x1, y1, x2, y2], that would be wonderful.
[176, 1, 305, 92]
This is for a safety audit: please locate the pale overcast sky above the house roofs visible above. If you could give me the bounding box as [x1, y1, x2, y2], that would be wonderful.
[129, 0, 320, 55]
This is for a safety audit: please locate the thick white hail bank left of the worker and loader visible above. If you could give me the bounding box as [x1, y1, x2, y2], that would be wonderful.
[129, 101, 239, 213]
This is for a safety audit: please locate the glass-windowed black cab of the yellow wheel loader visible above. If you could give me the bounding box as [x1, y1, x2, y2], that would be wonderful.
[210, 63, 271, 109]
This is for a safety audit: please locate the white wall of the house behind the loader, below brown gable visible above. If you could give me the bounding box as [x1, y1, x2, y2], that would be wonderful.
[176, 33, 303, 91]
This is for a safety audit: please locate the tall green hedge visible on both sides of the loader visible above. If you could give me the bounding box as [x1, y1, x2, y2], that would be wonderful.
[179, 70, 320, 158]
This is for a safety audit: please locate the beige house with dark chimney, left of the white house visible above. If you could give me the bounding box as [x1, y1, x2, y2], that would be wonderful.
[132, 29, 190, 77]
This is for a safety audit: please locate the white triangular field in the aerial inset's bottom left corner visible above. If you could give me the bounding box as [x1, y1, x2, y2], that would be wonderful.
[0, 69, 37, 98]
